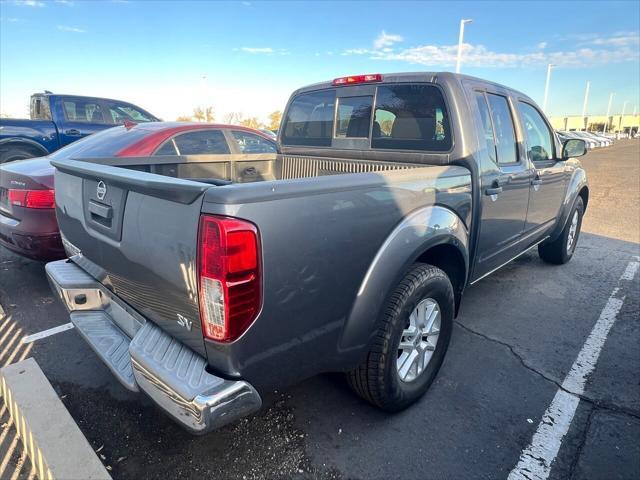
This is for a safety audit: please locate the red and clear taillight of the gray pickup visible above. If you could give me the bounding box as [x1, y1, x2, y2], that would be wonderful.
[198, 215, 262, 342]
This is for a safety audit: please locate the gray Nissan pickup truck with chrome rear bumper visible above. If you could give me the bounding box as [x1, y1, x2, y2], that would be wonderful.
[46, 73, 589, 433]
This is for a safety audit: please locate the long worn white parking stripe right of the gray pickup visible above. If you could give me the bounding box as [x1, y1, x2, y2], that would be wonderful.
[508, 259, 640, 480]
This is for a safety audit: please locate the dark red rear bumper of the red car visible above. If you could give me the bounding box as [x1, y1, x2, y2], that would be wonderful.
[0, 212, 66, 260]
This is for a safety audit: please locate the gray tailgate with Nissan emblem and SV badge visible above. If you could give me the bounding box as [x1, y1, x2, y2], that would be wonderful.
[52, 160, 209, 355]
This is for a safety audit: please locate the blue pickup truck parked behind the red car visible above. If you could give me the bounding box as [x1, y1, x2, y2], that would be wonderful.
[0, 91, 158, 163]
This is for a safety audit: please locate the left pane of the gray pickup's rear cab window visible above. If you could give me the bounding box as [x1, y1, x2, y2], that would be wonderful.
[282, 90, 336, 147]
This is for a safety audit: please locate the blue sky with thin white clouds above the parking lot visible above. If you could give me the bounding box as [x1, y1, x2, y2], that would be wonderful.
[0, 0, 640, 121]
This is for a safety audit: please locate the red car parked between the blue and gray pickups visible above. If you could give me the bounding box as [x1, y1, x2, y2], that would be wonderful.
[0, 122, 277, 260]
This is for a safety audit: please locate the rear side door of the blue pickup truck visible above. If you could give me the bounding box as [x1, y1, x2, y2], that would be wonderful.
[58, 97, 112, 146]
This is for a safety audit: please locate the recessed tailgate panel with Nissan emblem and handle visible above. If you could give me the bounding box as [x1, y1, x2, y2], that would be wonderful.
[82, 178, 127, 242]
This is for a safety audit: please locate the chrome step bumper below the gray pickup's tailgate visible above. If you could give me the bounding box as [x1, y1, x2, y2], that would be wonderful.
[46, 260, 262, 434]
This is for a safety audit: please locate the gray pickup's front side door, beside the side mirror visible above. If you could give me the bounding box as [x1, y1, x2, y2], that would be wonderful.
[518, 101, 567, 233]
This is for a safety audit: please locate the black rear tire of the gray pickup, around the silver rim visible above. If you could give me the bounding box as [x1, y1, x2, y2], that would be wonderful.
[347, 264, 455, 412]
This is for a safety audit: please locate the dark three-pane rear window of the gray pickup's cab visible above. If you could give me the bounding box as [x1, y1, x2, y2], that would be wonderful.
[282, 84, 453, 152]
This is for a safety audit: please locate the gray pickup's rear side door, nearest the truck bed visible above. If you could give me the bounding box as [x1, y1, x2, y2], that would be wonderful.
[472, 92, 533, 280]
